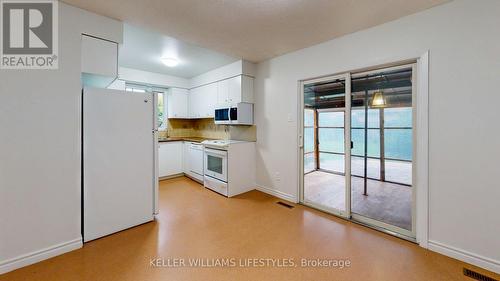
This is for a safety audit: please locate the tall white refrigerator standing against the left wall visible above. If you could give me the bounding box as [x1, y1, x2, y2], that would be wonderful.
[82, 88, 157, 242]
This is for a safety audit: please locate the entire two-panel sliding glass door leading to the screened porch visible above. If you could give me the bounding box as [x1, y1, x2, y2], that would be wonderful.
[299, 64, 415, 240]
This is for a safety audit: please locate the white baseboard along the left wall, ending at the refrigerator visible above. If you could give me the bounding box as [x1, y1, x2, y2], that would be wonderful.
[0, 238, 83, 274]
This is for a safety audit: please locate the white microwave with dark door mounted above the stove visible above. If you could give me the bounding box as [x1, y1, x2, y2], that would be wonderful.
[214, 102, 253, 125]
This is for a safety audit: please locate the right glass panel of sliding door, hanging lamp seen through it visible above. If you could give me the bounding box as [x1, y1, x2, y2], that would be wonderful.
[350, 65, 414, 237]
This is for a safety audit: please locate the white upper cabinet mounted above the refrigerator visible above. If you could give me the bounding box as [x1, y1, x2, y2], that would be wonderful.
[82, 35, 118, 79]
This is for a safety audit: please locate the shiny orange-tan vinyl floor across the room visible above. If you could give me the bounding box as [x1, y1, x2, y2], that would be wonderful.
[0, 177, 500, 281]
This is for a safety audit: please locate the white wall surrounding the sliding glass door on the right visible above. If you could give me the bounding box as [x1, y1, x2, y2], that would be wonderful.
[255, 0, 500, 272]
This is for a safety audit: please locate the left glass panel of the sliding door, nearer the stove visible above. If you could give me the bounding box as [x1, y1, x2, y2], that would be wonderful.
[302, 75, 350, 214]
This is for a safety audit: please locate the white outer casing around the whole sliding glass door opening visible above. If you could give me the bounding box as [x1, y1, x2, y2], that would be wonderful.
[296, 50, 430, 248]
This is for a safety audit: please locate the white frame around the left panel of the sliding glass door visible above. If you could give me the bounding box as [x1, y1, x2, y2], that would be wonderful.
[297, 72, 351, 219]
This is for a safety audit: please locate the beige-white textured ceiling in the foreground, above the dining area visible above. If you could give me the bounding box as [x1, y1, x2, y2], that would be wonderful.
[63, 0, 448, 62]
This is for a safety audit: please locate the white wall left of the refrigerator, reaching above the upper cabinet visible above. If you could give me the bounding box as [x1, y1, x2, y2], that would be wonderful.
[0, 2, 122, 273]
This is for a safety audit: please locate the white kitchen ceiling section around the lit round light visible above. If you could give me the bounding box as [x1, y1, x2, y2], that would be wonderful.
[119, 24, 238, 78]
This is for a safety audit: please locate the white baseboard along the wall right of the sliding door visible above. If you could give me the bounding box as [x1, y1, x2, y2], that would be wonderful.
[428, 240, 500, 274]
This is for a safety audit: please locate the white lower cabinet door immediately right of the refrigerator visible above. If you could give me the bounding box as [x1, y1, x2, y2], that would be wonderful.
[158, 141, 183, 177]
